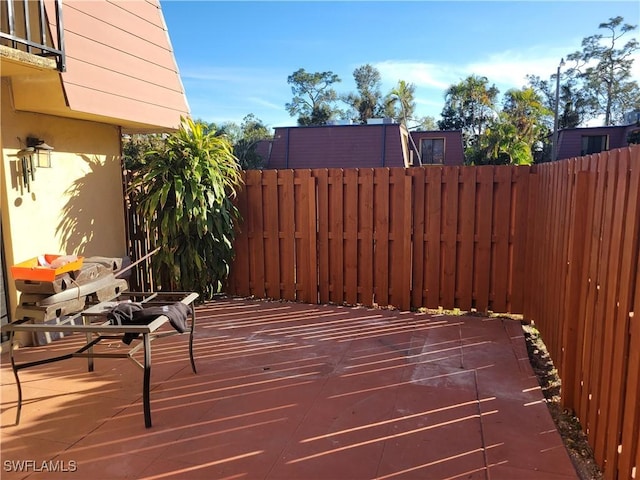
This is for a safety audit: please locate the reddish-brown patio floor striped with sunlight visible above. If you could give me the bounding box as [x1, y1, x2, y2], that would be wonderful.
[0, 298, 578, 480]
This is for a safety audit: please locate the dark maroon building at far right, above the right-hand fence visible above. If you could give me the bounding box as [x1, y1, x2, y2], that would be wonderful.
[558, 123, 640, 160]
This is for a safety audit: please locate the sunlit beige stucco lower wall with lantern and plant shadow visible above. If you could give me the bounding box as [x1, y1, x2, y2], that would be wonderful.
[0, 78, 127, 334]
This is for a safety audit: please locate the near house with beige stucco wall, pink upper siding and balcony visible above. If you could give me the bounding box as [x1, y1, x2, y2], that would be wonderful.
[0, 0, 189, 344]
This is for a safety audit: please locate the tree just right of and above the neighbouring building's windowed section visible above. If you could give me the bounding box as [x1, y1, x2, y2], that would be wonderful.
[438, 75, 500, 148]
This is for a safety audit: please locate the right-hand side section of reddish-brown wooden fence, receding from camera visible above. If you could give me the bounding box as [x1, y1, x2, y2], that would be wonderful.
[524, 146, 640, 480]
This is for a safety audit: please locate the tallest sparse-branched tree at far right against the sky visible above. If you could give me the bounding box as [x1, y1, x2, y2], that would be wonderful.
[567, 16, 640, 125]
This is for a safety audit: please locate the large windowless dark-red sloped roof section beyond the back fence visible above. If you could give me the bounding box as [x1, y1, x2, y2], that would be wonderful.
[265, 124, 406, 169]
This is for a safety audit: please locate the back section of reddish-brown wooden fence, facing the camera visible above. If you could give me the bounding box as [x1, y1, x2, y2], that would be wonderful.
[227, 166, 530, 312]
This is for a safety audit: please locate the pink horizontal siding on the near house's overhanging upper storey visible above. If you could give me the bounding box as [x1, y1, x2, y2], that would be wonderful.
[49, 0, 189, 129]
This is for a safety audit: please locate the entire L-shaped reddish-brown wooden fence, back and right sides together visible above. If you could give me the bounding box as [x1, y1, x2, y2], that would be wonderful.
[122, 146, 640, 480]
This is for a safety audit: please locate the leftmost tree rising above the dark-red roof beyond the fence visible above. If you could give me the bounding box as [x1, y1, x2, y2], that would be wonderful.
[285, 68, 341, 125]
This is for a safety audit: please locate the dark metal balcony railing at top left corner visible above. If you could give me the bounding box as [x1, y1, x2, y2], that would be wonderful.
[0, 0, 66, 72]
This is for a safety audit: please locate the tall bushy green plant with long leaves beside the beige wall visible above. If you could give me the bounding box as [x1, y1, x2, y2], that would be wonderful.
[131, 119, 242, 299]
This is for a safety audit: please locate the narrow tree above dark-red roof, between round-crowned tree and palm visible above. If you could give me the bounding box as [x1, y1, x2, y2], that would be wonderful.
[343, 64, 384, 123]
